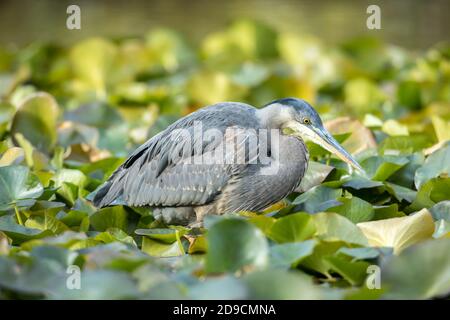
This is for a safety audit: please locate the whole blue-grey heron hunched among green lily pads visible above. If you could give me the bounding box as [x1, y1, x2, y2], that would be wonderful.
[94, 98, 362, 225]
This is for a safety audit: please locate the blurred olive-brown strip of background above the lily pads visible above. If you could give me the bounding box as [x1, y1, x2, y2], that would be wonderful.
[0, 0, 450, 49]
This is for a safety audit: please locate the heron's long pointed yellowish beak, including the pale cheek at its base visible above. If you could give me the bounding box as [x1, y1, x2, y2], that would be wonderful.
[287, 122, 365, 174]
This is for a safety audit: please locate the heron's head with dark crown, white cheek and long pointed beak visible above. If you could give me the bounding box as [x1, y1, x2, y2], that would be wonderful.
[266, 98, 364, 172]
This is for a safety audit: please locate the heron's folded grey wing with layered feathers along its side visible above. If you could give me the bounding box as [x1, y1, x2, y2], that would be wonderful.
[93, 120, 257, 206]
